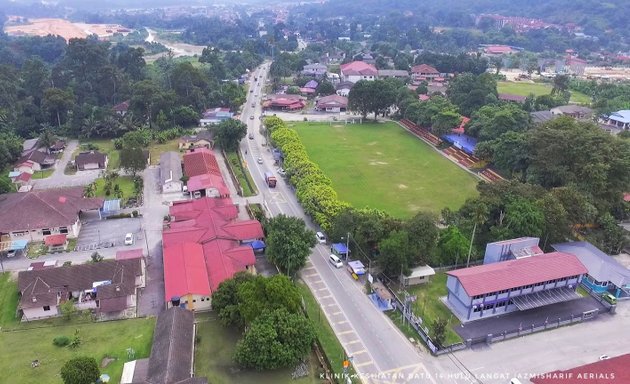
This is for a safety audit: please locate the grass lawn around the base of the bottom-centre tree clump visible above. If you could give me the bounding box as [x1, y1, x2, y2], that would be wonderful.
[195, 313, 320, 384]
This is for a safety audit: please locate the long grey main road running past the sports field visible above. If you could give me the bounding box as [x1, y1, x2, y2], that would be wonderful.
[241, 64, 469, 383]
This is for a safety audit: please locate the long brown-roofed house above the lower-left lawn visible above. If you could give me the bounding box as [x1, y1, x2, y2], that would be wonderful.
[18, 259, 144, 321]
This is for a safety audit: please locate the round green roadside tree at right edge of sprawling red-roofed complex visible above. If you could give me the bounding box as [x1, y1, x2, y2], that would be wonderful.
[265, 215, 316, 276]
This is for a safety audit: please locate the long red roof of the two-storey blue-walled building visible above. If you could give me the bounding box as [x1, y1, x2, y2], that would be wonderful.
[447, 252, 588, 296]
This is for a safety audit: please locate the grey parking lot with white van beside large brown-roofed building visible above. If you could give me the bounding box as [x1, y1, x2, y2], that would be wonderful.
[77, 218, 144, 251]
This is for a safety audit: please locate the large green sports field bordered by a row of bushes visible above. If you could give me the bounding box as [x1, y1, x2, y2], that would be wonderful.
[289, 122, 478, 218]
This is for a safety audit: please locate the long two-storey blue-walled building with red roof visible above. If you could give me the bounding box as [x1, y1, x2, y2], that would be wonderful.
[446, 252, 588, 322]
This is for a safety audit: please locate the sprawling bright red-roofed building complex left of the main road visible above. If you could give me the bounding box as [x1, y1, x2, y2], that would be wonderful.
[162, 197, 263, 310]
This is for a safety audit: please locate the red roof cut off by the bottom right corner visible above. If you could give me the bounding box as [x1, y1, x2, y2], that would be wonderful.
[530, 354, 630, 384]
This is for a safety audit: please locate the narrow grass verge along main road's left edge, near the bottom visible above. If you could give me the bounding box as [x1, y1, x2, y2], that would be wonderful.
[297, 282, 358, 382]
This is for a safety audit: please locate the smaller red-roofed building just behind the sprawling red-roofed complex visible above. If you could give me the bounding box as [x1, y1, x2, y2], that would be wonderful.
[184, 148, 230, 198]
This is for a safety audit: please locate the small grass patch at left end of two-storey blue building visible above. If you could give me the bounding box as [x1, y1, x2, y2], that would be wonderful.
[407, 272, 462, 345]
